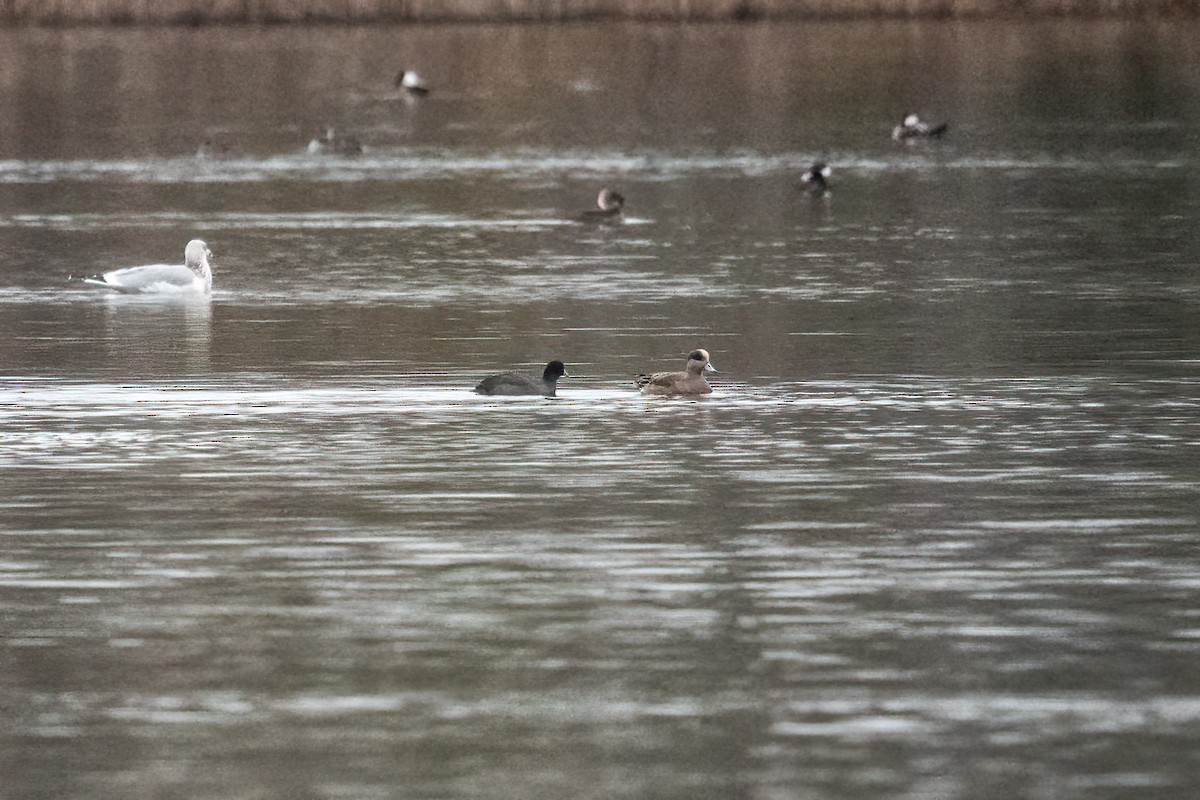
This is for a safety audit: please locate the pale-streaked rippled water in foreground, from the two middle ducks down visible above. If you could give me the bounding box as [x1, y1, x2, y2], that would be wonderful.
[7, 377, 1200, 796]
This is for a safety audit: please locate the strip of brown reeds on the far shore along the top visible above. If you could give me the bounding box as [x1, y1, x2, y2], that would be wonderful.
[0, 0, 1200, 26]
